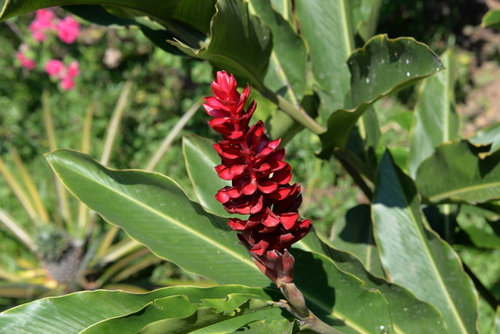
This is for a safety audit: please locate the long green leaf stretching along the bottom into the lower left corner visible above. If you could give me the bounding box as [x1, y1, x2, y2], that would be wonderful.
[0, 285, 282, 334]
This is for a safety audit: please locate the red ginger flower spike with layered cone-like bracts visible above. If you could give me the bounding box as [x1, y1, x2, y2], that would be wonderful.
[204, 71, 312, 284]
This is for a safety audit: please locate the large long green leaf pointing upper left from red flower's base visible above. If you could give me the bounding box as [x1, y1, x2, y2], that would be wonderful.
[47, 150, 269, 286]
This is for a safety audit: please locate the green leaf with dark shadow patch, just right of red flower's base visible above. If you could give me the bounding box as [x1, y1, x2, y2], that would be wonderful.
[292, 248, 391, 334]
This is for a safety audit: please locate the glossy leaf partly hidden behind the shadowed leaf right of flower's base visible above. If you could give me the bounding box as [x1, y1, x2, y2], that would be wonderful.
[301, 235, 448, 334]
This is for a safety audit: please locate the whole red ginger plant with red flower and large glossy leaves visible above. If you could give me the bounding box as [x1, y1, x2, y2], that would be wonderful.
[0, 0, 500, 334]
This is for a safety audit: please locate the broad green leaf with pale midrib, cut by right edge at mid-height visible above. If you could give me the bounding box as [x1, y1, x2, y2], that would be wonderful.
[416, 140, 500, 204]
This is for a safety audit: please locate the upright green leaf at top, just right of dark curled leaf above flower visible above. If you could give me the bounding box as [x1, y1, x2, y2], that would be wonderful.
[249, 0, 307, 105]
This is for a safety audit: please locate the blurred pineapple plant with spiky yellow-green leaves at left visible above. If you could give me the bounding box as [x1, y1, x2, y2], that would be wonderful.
[0, 79, 202, 306]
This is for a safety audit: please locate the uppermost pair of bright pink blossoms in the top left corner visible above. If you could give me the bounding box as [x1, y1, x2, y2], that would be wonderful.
[29, 9, 80, 44]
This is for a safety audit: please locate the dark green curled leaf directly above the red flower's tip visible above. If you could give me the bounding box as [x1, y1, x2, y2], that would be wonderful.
[172, 0, 272, 92]
